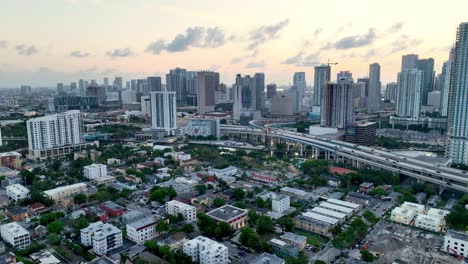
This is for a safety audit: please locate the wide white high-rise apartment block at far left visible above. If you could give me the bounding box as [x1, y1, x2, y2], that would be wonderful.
[26, 110, 84, 150]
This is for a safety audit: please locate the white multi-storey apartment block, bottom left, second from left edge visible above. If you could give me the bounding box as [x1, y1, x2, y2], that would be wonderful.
[80, 221, 123, 256]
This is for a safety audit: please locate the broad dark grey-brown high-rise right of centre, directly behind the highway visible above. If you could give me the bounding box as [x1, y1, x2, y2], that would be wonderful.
[320, 76, 356, 129]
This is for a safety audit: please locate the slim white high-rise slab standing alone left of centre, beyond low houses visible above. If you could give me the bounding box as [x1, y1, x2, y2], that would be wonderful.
[150, 91, 177, 135]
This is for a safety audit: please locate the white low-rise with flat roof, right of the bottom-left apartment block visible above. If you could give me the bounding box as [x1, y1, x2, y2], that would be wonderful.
[127, 216, 158, 245]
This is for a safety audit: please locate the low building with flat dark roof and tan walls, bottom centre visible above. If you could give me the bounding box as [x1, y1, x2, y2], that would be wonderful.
[207, 204, 248, 229]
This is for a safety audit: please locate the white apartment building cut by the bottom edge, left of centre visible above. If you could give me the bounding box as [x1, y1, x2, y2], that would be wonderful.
[182, 236, 229, 264]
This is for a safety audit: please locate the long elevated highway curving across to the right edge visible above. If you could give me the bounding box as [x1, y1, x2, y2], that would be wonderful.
[221, 125, 468, 193]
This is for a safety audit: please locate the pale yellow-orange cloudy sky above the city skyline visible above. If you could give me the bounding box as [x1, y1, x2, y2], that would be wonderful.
[0, 0, 468, 88]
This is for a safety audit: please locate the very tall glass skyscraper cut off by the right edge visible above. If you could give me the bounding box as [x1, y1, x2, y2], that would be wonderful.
[446, 22, 468, 164]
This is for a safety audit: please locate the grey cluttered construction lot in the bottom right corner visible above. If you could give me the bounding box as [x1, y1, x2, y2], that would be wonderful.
[363, 221, 460, 264]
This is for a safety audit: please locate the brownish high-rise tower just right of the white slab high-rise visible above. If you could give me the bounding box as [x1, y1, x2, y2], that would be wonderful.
[197, 71, 219, 115]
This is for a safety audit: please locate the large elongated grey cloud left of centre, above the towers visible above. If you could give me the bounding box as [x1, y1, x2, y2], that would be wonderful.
[146, 27, 226, 54]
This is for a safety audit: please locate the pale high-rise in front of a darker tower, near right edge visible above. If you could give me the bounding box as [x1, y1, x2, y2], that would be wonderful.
[395, 68, 424, 119]
